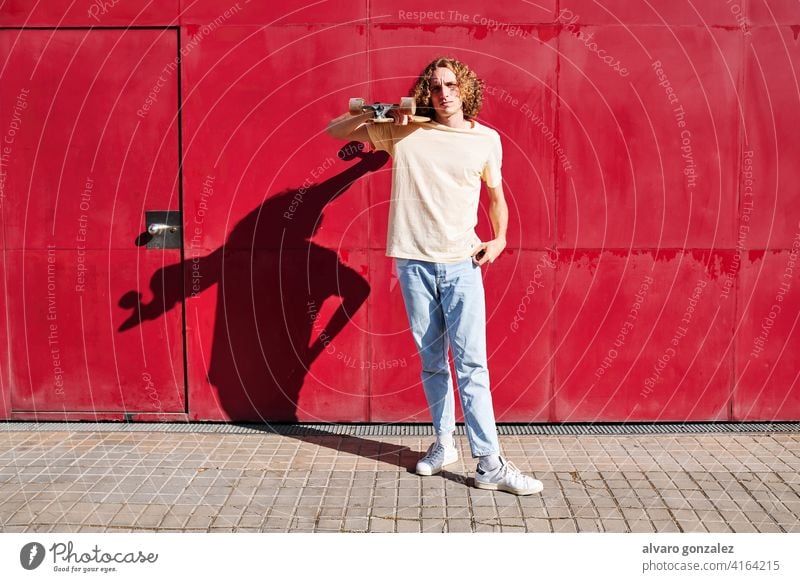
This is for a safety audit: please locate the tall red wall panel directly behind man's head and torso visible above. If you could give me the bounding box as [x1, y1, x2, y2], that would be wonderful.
[365, 26, 556, 249]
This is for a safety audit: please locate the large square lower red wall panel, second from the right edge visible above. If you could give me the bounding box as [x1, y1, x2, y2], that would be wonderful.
[555, 251, 733, 421]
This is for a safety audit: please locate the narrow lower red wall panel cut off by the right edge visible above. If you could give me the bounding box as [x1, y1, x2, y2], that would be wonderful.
[733, 249, 800, 420]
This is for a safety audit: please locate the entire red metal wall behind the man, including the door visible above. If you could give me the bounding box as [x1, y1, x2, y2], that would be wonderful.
[0, 0, 800, 422]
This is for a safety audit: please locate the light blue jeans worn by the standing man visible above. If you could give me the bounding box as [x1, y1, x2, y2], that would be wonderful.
[395, 257, 500, 457]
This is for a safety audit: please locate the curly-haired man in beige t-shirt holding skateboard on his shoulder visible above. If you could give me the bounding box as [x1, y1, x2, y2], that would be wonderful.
[327, 57, 542, 495]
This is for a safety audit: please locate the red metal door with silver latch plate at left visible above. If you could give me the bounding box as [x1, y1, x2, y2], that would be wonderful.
[0, 28, 186, 419]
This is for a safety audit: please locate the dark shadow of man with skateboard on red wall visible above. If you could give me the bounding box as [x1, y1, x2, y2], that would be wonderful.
[119, 142, 388, 422]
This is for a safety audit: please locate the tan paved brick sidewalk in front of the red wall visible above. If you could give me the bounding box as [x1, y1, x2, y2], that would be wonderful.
[0, 425, 800, 532]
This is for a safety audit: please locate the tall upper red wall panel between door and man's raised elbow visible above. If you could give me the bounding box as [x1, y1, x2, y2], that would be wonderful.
[183, 26, 376, 250]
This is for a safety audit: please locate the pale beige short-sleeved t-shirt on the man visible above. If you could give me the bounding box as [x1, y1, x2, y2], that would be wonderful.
[367, 121, 503, 263]
